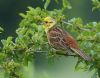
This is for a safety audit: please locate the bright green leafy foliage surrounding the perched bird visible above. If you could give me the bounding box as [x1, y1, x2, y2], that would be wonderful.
[0, 0, 100, 78]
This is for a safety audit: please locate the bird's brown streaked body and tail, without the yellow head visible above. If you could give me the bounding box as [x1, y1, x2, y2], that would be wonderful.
[47, 26, 90, 60]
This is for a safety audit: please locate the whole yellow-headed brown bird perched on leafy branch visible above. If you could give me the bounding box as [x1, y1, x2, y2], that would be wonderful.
[43, 16, 91, 61]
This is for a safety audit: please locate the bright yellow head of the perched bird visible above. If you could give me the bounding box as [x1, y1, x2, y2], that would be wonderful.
[43, 16, 56, 32]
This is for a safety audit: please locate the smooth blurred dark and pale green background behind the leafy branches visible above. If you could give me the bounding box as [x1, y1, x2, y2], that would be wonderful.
[0, 0, 100, 78]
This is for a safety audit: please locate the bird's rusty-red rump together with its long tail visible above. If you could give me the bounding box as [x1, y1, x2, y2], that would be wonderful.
[64, 32, 91, 61]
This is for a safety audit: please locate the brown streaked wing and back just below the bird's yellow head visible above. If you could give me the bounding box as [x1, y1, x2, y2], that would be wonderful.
[48, 28, 68, 49]
